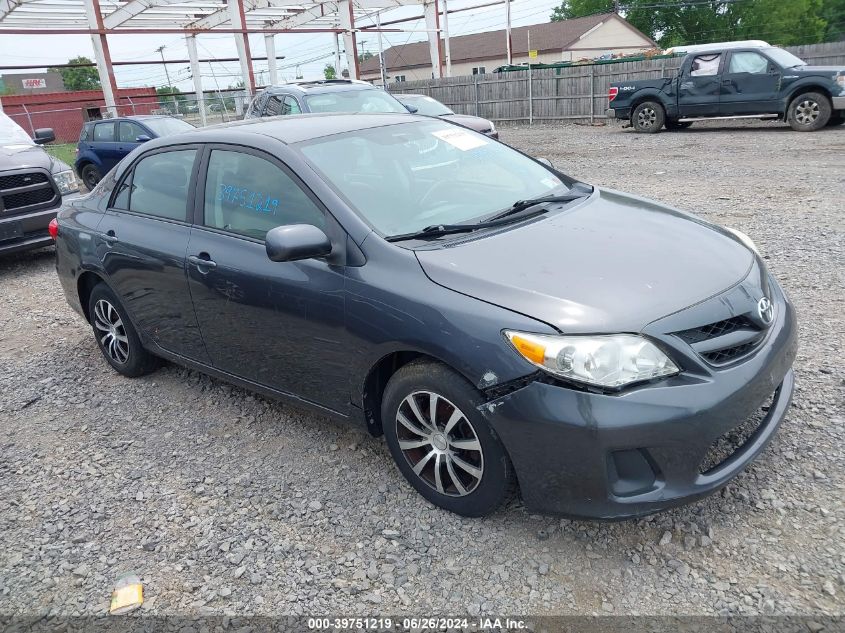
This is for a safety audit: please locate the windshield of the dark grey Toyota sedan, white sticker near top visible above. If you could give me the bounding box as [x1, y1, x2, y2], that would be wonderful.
[299, 121, 571, 235]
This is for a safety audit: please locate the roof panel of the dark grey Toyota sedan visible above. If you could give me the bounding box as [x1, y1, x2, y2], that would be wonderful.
[156, 112, 422, 145]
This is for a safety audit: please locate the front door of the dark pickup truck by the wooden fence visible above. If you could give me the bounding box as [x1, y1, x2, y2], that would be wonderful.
[719, 51, 781, 116]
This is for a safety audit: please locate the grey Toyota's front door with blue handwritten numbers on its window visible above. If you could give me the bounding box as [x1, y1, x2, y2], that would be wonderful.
[188, 146, 350, 412]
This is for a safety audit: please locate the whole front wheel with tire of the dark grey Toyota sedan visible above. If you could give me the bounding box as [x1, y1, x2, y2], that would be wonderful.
[382, 361, 516, 517]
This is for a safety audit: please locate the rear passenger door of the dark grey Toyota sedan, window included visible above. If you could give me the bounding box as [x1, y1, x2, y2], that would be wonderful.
[98, 145, 209, 364]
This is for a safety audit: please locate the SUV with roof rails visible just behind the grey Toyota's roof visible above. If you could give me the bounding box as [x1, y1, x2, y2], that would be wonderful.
[244, 79, 416, 119]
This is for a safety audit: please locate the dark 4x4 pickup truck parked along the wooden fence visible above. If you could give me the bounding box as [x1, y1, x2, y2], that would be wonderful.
[607, 42, 845, 133]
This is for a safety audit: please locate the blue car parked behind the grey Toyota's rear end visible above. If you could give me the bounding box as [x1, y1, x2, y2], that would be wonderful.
[74, 115, 194, 190]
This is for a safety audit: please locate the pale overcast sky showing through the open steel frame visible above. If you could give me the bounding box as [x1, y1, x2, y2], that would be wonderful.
[0, 0, 560, 92]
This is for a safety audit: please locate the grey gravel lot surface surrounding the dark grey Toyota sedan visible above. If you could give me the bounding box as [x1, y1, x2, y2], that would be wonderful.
[0, 123, 845, 615]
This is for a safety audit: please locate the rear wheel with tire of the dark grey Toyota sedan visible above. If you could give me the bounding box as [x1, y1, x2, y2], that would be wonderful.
[88, 283, 158, 378]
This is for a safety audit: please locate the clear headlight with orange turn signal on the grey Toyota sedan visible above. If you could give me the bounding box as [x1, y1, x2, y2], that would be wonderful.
[505, 331, 680, 387]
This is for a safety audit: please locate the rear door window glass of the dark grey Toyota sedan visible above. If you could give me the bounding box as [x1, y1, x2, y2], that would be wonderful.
[126, 149, 197, 222]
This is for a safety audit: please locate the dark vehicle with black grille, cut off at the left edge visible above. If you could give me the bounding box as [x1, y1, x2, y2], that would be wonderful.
[0, 112, 79, 254]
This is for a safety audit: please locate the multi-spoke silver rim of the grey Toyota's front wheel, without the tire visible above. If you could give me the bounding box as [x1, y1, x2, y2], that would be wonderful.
[396, 391, 484, 497]
